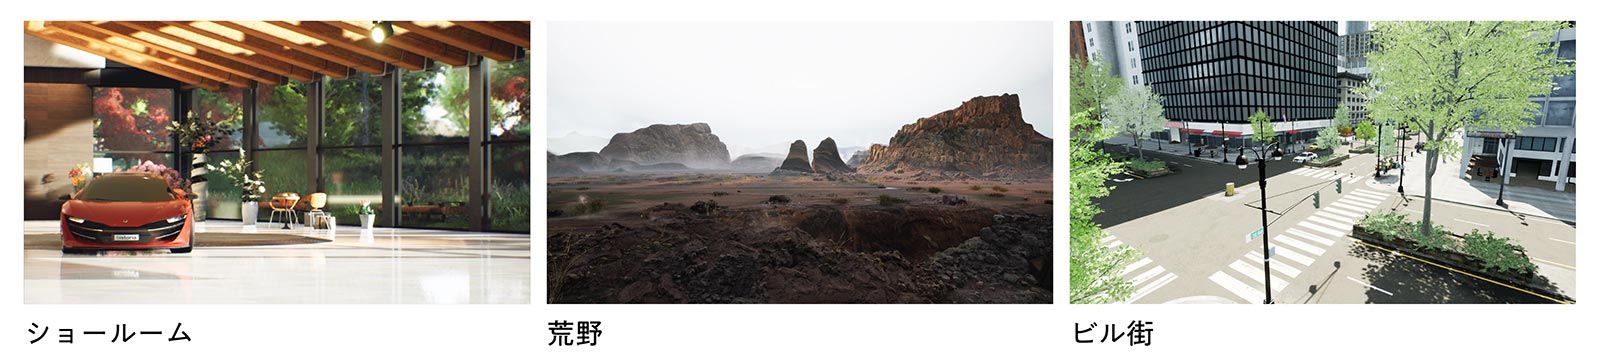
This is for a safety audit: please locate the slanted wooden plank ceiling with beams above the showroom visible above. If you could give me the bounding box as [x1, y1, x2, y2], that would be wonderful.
[22, 21, 530, 90]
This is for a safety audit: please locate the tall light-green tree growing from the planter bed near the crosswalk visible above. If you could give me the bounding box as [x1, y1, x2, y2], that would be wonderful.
[1368, 21, 1573, 235]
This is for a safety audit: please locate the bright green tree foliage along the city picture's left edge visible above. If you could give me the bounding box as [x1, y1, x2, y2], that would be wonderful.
[1067, 111, 1138, 304]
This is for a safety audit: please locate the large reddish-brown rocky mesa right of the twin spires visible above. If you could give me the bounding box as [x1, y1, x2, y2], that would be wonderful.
[858, 95, 1053, 179]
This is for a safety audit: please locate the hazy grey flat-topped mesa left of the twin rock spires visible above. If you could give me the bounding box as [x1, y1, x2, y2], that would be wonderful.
[600, 123, 728, 168]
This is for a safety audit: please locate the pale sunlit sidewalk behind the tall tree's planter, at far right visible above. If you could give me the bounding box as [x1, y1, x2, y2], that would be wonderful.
[1389, 149, 1578, 224]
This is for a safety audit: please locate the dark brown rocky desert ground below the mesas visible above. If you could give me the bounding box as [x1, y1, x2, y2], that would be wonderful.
[547, 173, 1053, 303]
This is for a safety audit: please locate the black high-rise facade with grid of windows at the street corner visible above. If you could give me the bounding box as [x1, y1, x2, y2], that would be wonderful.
[1138, 21, 1339, 146]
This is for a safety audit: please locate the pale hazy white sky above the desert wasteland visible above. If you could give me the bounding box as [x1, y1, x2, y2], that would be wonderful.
[547, 22, 1053, 157]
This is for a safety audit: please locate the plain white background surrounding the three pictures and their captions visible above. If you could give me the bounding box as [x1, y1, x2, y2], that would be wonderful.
[0, 0, 1595, 352]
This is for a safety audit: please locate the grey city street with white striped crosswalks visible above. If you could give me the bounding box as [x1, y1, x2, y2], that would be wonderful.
[1098, 143, 1578, 303]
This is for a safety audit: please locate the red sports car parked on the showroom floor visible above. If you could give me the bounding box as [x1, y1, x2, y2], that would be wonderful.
[61, 173, 194, 253]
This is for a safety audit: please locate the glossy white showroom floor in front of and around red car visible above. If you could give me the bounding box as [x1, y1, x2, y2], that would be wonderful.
[22, 221, 531, 304]
